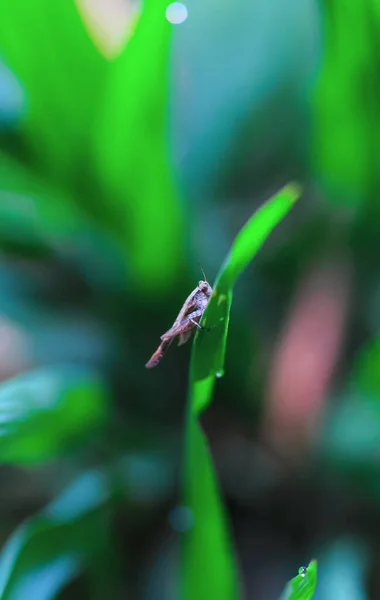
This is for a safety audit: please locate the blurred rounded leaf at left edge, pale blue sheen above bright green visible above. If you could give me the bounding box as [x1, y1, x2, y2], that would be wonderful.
[0, 367, 108, 464]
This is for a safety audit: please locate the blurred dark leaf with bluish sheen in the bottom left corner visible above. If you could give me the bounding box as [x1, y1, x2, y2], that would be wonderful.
[0, 471, 114, 600]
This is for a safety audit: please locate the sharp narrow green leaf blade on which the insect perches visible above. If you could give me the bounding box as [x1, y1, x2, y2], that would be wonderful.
[181, 184, 300, 600]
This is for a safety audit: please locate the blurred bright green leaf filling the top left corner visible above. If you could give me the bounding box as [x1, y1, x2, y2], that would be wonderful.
[0, 0, 107, 178]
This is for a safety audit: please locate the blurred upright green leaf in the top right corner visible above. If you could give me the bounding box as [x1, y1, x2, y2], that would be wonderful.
[312, 0, 380, 206]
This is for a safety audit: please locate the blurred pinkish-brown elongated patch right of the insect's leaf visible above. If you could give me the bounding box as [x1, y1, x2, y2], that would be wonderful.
[262, 258, 351, 460]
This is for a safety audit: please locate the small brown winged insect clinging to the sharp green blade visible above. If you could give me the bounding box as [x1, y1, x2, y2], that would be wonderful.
[145, 273, 212, 369]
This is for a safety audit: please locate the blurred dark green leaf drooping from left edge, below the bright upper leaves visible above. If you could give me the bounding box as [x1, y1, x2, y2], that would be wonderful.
[0, 153, 125, 286]
